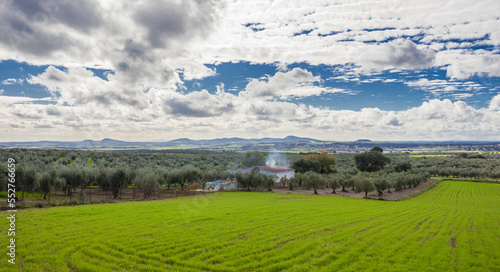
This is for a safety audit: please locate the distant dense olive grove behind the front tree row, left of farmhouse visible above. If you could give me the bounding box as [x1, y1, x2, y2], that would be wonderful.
[0, 149, 243, 181]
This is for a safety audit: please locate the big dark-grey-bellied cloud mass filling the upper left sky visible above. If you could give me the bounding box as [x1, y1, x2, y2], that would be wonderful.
[0, 0, 223, 89]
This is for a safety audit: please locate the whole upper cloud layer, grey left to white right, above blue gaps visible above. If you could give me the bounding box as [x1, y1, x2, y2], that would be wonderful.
[0, 0, 500, 79]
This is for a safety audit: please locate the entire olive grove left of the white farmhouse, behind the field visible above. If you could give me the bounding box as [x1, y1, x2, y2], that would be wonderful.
[0, 149, 250, 199]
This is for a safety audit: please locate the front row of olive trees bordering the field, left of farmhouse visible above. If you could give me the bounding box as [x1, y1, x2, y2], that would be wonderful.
[0, 164, 207, 200]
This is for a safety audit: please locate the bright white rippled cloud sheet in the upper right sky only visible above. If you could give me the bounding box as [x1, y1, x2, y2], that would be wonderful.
[203, 0, 500, 76]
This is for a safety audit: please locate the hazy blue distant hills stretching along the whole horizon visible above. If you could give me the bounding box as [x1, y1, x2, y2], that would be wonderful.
[0, 136, 500, 151]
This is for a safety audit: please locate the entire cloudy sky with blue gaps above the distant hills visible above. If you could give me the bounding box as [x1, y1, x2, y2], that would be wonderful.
[0, 0, 500, 142]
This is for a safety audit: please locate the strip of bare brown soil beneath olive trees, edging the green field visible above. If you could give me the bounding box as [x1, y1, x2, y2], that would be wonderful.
[273, 180, 438, 201]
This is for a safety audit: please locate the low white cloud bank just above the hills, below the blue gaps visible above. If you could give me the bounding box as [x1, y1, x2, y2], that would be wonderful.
[0, 89, 500, 140]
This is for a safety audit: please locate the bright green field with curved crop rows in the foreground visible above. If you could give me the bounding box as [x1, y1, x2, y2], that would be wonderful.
[0, 181, 500, 272]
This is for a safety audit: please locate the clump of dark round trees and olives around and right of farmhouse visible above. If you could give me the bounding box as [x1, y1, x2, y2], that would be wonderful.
[236, 146, 428, 197]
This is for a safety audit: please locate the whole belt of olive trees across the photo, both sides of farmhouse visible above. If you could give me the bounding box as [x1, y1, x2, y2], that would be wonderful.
[0, 146, 500, 201]
